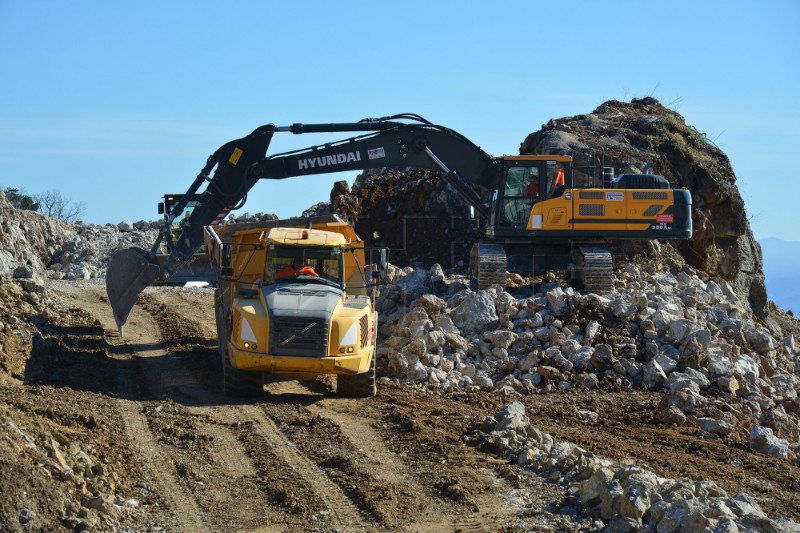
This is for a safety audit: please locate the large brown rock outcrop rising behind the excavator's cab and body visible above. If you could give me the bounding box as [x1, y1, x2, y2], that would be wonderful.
[520, 98, 768, 318]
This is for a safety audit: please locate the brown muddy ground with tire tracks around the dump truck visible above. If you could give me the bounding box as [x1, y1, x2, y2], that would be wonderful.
[0, 282, 800, 531]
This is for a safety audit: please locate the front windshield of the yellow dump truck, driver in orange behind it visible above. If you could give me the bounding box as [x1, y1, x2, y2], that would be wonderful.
[264, 245, 343, 287]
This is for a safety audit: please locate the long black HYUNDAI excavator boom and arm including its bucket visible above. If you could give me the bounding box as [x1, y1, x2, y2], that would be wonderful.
[106, 114, 496, 335]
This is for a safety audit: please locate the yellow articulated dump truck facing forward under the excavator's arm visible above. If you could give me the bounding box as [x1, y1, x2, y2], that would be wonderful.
[204, 216, 387, 397]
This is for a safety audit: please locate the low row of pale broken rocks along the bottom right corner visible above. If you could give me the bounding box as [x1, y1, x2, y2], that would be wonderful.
[481, 402, 800, 533]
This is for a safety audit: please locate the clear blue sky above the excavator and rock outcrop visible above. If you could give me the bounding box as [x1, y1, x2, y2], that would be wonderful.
[0, 0, 800, 240]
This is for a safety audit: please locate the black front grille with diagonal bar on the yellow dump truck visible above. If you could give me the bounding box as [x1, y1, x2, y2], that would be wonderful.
[269, 317, 328, 357]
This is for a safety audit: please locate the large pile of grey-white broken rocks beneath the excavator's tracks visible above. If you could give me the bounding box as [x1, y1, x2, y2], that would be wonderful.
[378, 261, 800, 461]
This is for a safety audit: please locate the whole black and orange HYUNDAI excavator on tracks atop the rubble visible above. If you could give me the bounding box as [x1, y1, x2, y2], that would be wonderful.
[106, 114, 692, 332]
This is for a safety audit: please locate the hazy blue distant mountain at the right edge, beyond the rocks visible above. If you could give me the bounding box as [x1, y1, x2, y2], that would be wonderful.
[759, 237, 800, 316]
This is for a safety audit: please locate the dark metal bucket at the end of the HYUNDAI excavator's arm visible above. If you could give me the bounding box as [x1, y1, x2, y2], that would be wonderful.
[106, 248, 161, 336]
